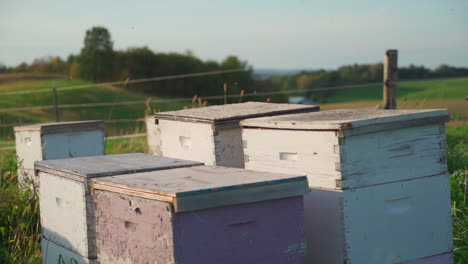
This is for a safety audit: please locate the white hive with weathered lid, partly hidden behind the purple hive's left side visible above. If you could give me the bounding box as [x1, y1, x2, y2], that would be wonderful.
[35, 153, 202, 264]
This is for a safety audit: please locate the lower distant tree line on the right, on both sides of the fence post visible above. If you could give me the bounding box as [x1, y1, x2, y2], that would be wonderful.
[266, 63, 468, 103]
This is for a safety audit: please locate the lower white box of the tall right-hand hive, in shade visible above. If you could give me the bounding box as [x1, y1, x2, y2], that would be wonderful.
[304, 174, 452, 264]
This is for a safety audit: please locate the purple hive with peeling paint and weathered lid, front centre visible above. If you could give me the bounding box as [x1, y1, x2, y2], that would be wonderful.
[92, 166, 308, 264]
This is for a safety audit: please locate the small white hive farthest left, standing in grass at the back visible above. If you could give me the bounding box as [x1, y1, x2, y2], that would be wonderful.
[14, 121, 105, 189]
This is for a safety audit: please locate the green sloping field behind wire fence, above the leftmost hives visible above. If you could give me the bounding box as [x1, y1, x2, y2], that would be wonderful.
[0, 79, 196, 141]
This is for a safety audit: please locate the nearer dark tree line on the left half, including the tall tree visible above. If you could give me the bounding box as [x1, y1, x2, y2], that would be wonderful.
[0, 27, 254, 97]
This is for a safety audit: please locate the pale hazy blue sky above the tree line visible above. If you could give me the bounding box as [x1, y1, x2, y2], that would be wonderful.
[0, 0, 468, 69]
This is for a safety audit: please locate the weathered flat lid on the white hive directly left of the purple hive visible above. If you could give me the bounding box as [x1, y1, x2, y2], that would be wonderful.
[34, 153, 203, 180]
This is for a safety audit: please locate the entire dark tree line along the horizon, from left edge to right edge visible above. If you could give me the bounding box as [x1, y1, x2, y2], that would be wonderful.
[0, 27, 468, 101]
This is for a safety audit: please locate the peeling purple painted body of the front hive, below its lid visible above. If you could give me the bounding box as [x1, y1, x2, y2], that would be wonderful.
[95, 190, 305, 264]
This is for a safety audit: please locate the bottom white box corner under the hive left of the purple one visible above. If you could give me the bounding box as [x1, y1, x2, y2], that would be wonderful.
[41, 237, 98, 264]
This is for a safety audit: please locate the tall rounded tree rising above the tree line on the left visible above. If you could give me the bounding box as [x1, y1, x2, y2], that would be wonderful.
[78, 27, 114, 81]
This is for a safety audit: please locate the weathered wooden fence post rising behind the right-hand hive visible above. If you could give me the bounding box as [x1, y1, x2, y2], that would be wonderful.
[383, 49, 398, 109]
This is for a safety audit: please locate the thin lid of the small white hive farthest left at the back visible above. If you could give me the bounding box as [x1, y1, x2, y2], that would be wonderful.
[14, 120, 104, 134]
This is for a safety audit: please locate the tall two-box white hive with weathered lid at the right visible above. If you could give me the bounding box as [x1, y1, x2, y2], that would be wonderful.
[241, 110, 452, 263]
